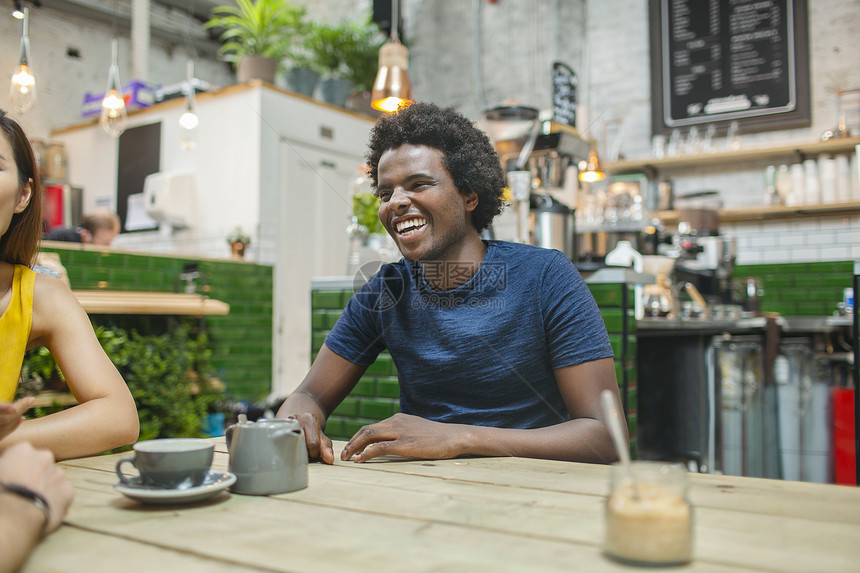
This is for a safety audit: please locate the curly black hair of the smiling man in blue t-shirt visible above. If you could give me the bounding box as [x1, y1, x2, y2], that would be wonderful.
[366, 102, 506, 232]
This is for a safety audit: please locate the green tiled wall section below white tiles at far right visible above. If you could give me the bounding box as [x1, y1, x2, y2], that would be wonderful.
[732, 261, 854, 316]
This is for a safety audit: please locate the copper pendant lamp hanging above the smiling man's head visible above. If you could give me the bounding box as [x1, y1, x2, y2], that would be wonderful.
[370, 0, 412, 112]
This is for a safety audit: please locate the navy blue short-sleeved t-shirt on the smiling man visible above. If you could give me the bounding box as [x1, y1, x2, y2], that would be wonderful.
[325, 241, 612, 428]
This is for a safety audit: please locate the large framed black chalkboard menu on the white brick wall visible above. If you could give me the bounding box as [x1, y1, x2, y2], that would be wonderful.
[650, 0, 810, 133]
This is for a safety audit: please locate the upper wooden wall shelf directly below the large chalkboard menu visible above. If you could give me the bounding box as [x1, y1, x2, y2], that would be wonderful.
[602, 137, 860, 173]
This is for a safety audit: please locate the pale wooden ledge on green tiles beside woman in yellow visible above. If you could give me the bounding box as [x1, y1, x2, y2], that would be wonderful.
[72, 290, 230, 316]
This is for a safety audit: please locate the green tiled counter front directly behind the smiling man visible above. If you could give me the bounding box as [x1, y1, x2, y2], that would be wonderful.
[311, 284, 636, 457]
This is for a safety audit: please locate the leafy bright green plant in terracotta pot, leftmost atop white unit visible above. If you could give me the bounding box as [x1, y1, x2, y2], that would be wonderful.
[204, 0, 305, 83]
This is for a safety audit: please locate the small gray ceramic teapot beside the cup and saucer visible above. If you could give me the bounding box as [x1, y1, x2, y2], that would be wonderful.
[226, 416, 308, 495]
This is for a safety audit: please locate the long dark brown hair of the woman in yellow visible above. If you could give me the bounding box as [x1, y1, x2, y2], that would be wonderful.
[0, 109, 42, 266]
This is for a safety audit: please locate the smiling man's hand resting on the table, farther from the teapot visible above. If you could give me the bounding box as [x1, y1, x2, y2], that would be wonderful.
[340, 414, 466, 462]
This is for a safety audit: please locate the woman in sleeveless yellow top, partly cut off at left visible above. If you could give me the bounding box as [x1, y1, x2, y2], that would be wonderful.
[0, 110, 139, 459]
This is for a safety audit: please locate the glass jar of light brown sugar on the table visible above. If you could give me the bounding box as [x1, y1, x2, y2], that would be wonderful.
[604, 461, 693, 566]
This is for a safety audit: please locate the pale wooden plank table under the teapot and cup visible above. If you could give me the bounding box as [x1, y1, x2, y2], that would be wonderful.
[24, 438, 860, 573]
